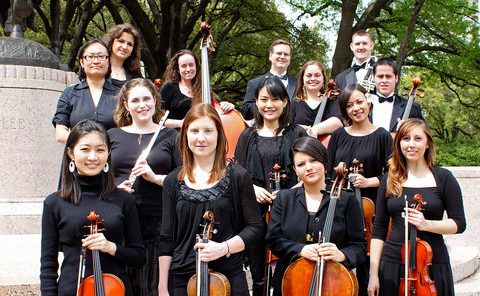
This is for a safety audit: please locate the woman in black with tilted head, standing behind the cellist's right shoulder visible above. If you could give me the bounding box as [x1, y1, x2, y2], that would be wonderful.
[327, 84, 392, 295]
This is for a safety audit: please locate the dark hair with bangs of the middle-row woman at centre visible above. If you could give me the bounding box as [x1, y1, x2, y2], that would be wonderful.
[254, 76, 291, 136]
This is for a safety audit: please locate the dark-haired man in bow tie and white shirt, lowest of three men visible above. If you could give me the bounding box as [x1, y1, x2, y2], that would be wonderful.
[371, 58, 424, 132]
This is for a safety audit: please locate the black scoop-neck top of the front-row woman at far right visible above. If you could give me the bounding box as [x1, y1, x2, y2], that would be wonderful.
[372, 166, 467, 264]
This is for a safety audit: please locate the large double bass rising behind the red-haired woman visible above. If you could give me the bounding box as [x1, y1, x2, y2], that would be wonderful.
[200, 22, 247, 159]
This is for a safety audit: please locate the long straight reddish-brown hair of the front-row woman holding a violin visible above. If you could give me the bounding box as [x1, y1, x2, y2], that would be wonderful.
[178, 104, 228, 183]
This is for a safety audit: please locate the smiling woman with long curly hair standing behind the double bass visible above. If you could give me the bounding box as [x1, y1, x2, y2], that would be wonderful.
[160, 49, 234, 128]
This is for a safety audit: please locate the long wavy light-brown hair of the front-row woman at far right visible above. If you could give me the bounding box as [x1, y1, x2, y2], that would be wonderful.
[386, 118, 435, 197]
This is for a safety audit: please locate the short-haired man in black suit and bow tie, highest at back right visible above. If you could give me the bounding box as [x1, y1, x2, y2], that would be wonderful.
[335, 30, 375, 92]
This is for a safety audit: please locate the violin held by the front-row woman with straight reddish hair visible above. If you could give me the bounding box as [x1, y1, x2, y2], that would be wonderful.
[187, 211, 230, 296]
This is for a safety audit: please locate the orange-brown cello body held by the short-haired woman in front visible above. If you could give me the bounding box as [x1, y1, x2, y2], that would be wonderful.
[282, 258, 358, 296]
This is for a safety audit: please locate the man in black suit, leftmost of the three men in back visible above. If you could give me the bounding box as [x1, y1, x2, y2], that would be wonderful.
[242, 39, 297, 120]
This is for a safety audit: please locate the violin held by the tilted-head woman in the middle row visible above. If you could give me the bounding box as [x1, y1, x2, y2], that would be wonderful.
[349, 158, 375, 256]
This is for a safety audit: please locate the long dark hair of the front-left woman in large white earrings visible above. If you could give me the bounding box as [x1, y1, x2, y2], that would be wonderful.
[58, 119, 116, 204]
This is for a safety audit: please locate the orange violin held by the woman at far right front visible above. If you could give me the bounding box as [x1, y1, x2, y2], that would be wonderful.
[399, 193, 437, 296]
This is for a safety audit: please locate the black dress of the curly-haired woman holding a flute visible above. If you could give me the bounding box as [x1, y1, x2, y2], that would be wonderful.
[108, 128, 182, 296]
